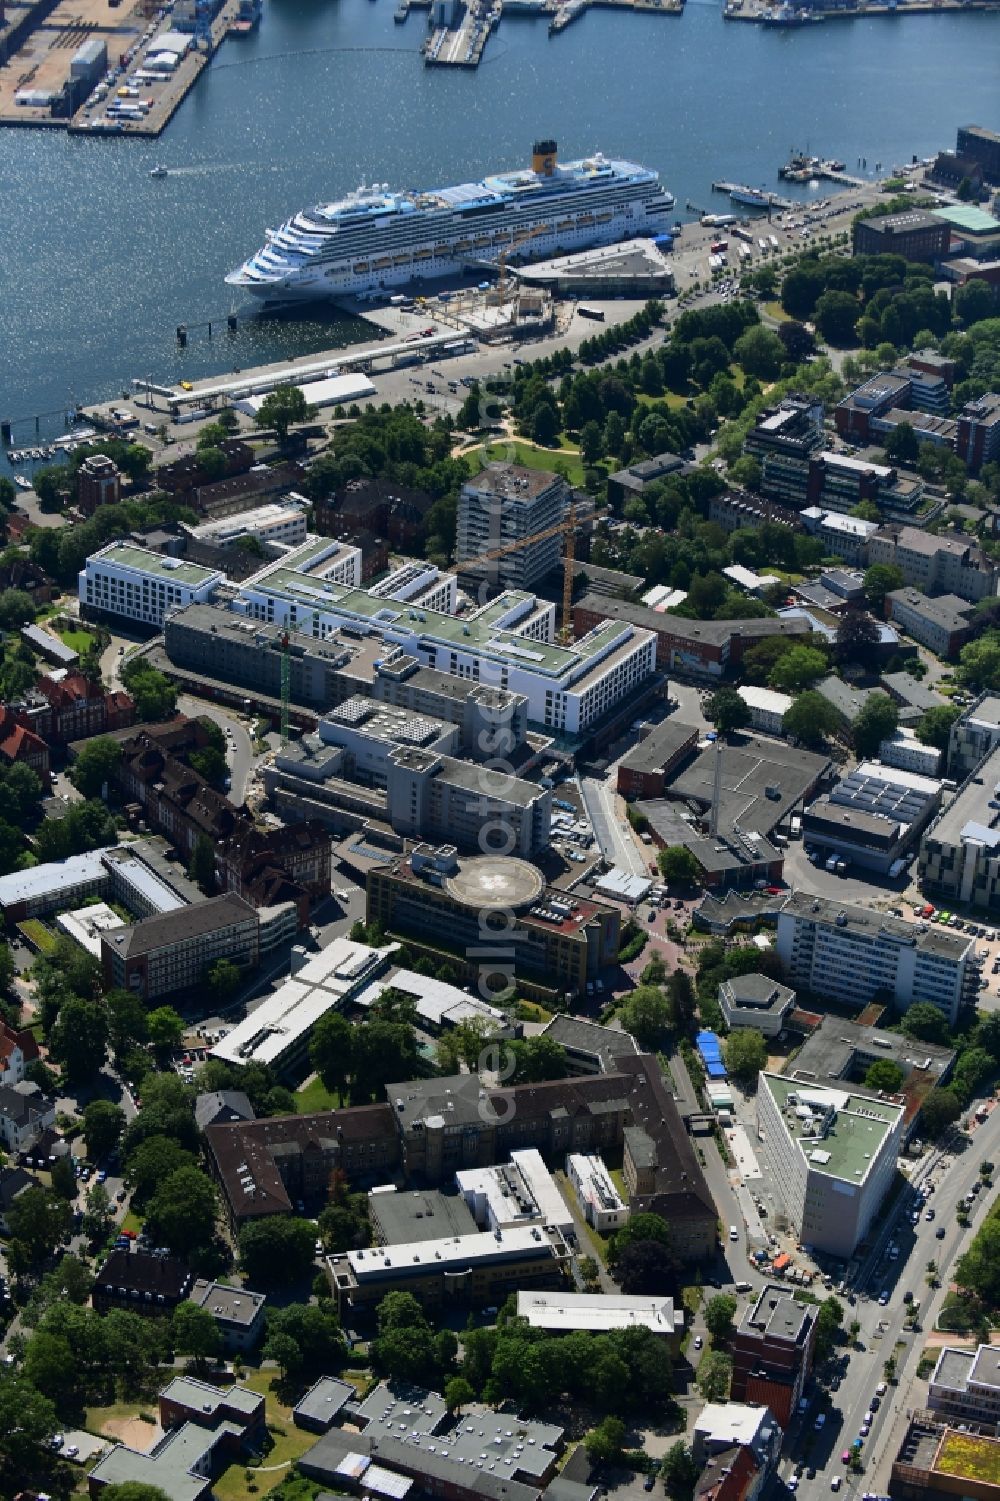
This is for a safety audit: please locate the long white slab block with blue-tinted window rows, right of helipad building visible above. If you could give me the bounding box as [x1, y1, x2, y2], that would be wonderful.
[776, 892, 979, 1025]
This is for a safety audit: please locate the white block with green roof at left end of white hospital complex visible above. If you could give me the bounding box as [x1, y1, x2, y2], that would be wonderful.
[78, 542, 227, 627]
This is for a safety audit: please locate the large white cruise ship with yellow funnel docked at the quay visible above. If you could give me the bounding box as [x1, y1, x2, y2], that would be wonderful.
[225, 141, 674, 302]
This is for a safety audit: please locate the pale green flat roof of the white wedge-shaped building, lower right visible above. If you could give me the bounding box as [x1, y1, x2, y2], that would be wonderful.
[761, 1073, 902, 1184]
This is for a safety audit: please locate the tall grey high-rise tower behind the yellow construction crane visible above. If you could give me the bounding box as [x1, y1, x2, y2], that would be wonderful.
[455, 464, 571, 588]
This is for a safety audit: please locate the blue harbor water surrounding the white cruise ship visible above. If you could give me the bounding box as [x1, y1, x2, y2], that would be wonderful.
[0, 0, 1000, 444]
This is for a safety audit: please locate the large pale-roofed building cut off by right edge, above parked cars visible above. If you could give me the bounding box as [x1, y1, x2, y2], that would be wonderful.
[917, 741, 1000, 911]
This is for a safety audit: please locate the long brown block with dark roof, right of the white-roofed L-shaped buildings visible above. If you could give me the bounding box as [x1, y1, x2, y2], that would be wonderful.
[101, 892, 260, 1001]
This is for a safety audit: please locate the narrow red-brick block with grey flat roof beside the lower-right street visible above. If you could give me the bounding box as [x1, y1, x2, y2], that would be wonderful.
[730, 1283, 817, 1427]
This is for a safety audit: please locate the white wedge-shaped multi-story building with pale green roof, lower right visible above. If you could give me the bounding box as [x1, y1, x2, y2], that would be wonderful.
[757, 1073, 904, 1256]
